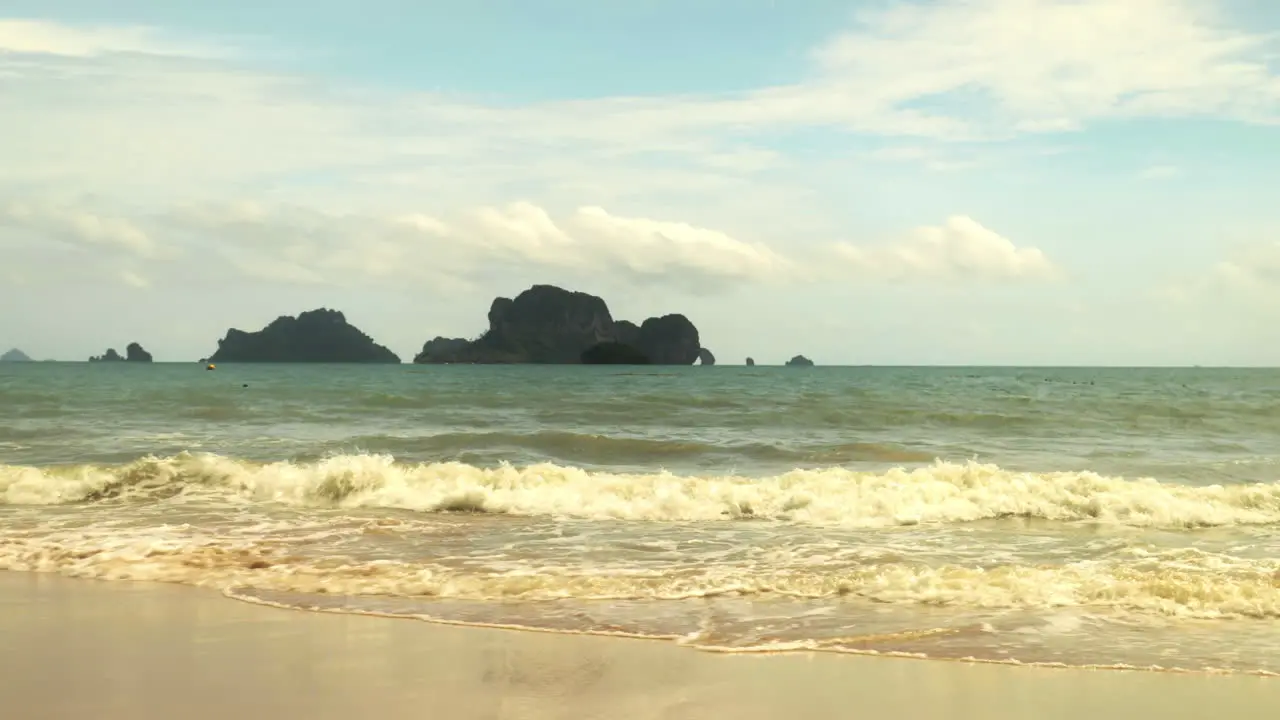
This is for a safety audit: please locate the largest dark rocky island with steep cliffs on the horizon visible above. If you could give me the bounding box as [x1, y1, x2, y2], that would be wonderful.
[413, 284, 716, 365]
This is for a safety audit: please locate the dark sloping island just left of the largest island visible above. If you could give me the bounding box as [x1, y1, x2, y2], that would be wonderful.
[207, 307, 399, 363]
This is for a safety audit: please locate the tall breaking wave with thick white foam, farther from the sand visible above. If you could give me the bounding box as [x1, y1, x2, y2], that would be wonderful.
[0, 452, 1280, 529]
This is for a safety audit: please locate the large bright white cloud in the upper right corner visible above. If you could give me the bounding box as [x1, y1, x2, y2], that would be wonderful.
[817, 0, 1280, 132]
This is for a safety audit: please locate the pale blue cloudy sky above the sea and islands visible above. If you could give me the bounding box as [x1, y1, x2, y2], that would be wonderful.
[0, 0, 1280, 365]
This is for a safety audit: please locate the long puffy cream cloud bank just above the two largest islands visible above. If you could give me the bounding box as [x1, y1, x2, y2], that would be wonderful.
[149, 197, 795, 288]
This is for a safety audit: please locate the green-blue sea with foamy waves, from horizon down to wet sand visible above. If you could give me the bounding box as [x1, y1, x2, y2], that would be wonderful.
[0, 363, 1280, 675]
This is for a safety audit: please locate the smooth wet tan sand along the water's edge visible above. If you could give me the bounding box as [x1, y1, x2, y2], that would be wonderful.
[0, 571, 1280, 720]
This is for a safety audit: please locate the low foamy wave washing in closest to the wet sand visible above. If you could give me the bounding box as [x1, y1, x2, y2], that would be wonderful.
[0, 528, 1280, 619]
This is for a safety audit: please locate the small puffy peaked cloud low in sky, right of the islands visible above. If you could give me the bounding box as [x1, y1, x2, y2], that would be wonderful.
[833, 215, 1061, 281]
